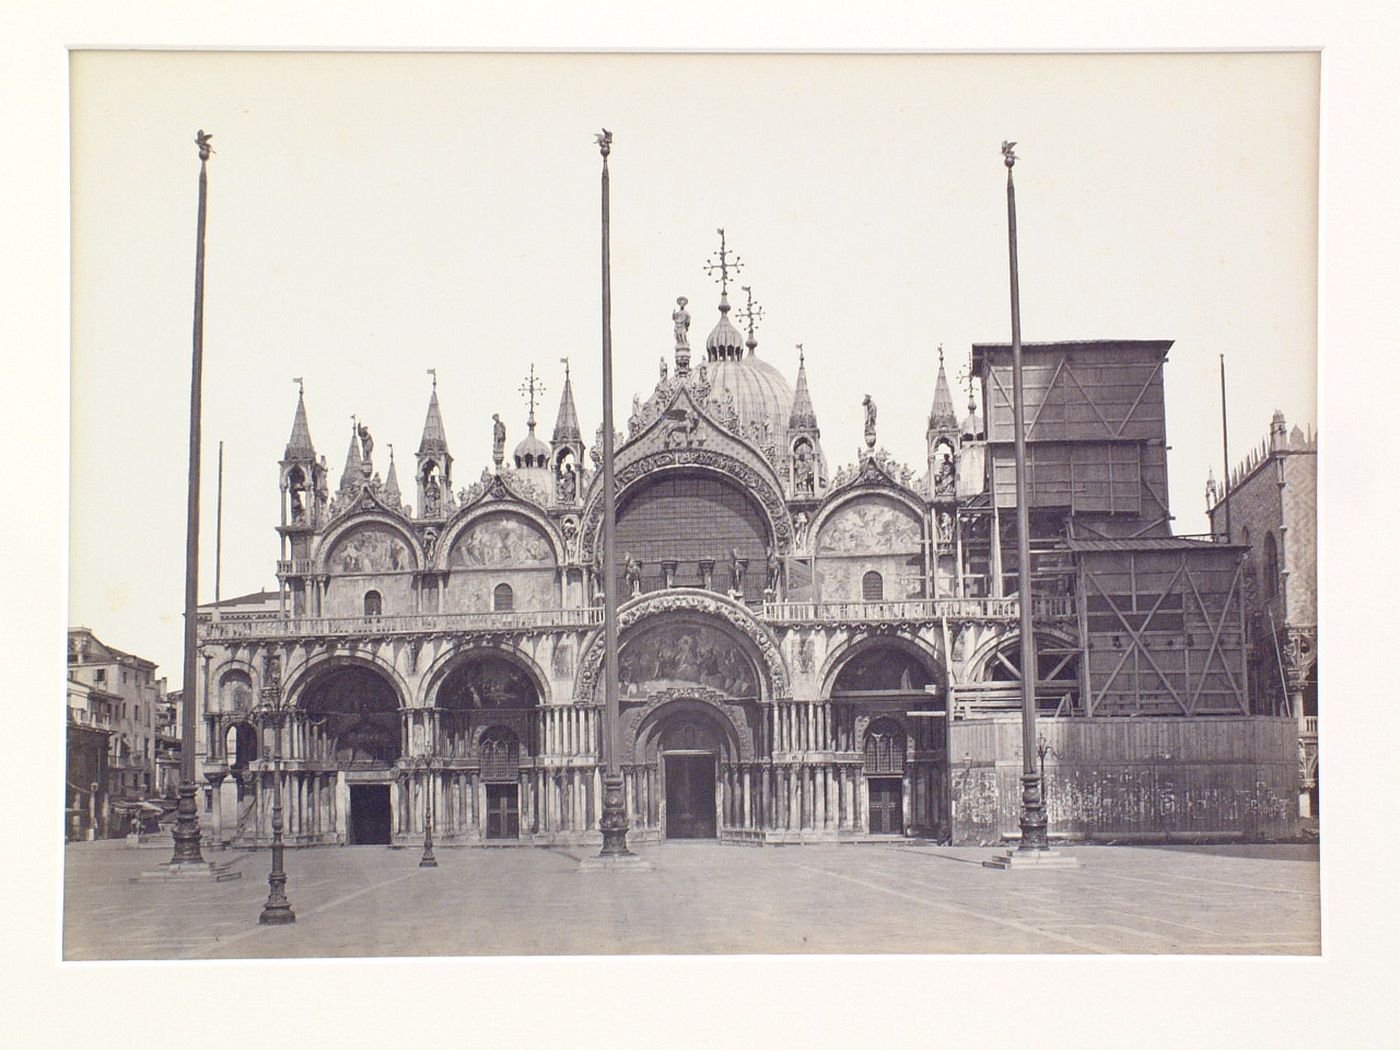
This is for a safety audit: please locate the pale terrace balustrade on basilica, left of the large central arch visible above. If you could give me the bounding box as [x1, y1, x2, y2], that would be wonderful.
[200, 608, 603, 641]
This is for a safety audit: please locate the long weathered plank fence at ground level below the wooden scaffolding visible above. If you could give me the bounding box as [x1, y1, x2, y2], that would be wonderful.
[948, 717, 1298, 846]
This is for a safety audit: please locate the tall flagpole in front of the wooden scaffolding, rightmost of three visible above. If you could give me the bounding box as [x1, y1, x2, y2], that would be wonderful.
[1001, 143, 1049, 853]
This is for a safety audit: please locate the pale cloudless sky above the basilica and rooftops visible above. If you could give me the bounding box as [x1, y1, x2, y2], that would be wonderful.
[69, 52, 1319, 687]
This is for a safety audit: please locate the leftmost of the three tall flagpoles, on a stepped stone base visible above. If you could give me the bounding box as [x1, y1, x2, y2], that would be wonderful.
[171, 129, 213, 868]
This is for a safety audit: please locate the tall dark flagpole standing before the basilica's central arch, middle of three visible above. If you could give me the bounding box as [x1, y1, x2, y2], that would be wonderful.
[598, 127, 631, 857]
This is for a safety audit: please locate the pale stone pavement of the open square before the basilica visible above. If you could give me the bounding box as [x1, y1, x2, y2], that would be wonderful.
[63, 843, 1320, 960]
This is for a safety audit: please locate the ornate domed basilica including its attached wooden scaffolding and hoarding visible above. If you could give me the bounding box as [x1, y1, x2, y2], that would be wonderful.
[197, 281, 1296, 846]
